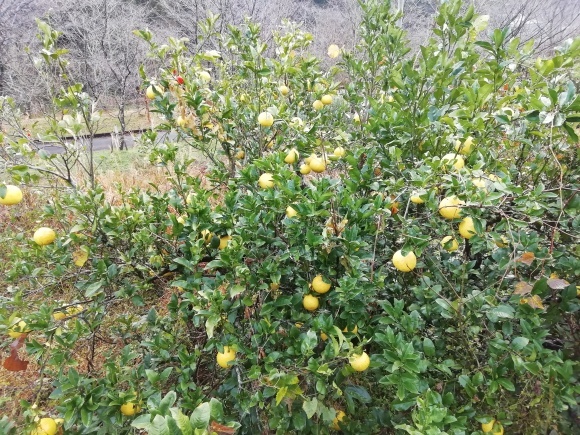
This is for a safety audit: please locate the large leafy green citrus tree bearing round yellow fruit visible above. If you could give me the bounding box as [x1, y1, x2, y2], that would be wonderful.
[0, 1, 580, 434]
